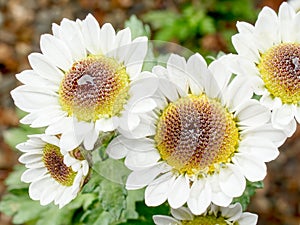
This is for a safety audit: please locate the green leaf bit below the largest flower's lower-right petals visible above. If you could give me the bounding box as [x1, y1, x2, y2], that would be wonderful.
[233, 181, 264, 210]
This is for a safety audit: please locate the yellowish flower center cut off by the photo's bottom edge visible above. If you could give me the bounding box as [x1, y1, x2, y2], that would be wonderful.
[181, 215, 232, 225]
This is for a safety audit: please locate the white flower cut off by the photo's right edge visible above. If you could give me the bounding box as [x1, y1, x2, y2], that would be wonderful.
[232, 2, 300, 136]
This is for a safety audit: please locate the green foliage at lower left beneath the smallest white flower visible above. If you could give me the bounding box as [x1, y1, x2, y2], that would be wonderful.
[0, 161, 149, 225]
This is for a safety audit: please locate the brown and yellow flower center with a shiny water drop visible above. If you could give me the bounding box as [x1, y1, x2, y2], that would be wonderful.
[59, 56, 129, 122]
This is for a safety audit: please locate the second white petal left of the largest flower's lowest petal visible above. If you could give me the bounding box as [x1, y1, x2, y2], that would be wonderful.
[145, 173, 175, 206]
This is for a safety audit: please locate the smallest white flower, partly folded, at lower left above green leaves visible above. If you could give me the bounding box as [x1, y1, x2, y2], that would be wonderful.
[17, 135, 89, 208]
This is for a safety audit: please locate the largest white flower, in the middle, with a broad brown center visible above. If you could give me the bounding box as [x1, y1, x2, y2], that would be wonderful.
[107, 54, 286, 215]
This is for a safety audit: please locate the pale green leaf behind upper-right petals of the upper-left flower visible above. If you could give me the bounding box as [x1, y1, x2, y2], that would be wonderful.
[125, 15, 151, 39]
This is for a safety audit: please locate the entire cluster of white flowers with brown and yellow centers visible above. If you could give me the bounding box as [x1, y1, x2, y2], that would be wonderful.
[11, 3, 300, 225]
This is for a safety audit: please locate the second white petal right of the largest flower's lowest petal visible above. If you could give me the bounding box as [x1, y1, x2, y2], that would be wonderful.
[219, 163, 246, 197]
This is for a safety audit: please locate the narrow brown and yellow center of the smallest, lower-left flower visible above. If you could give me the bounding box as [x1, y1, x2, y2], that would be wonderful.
[43, 144, 76, 186]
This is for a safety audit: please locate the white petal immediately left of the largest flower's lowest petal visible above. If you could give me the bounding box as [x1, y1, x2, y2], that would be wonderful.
[168, 175, 190, 209]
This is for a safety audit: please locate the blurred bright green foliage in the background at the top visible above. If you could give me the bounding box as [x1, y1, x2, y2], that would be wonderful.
[143, 0, 257, 54]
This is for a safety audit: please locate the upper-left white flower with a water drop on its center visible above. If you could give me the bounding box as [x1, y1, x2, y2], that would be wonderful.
[11, 15, 157, 150]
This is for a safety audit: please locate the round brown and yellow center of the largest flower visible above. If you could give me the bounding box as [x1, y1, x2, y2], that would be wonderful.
[154, 94, 239, 175]
